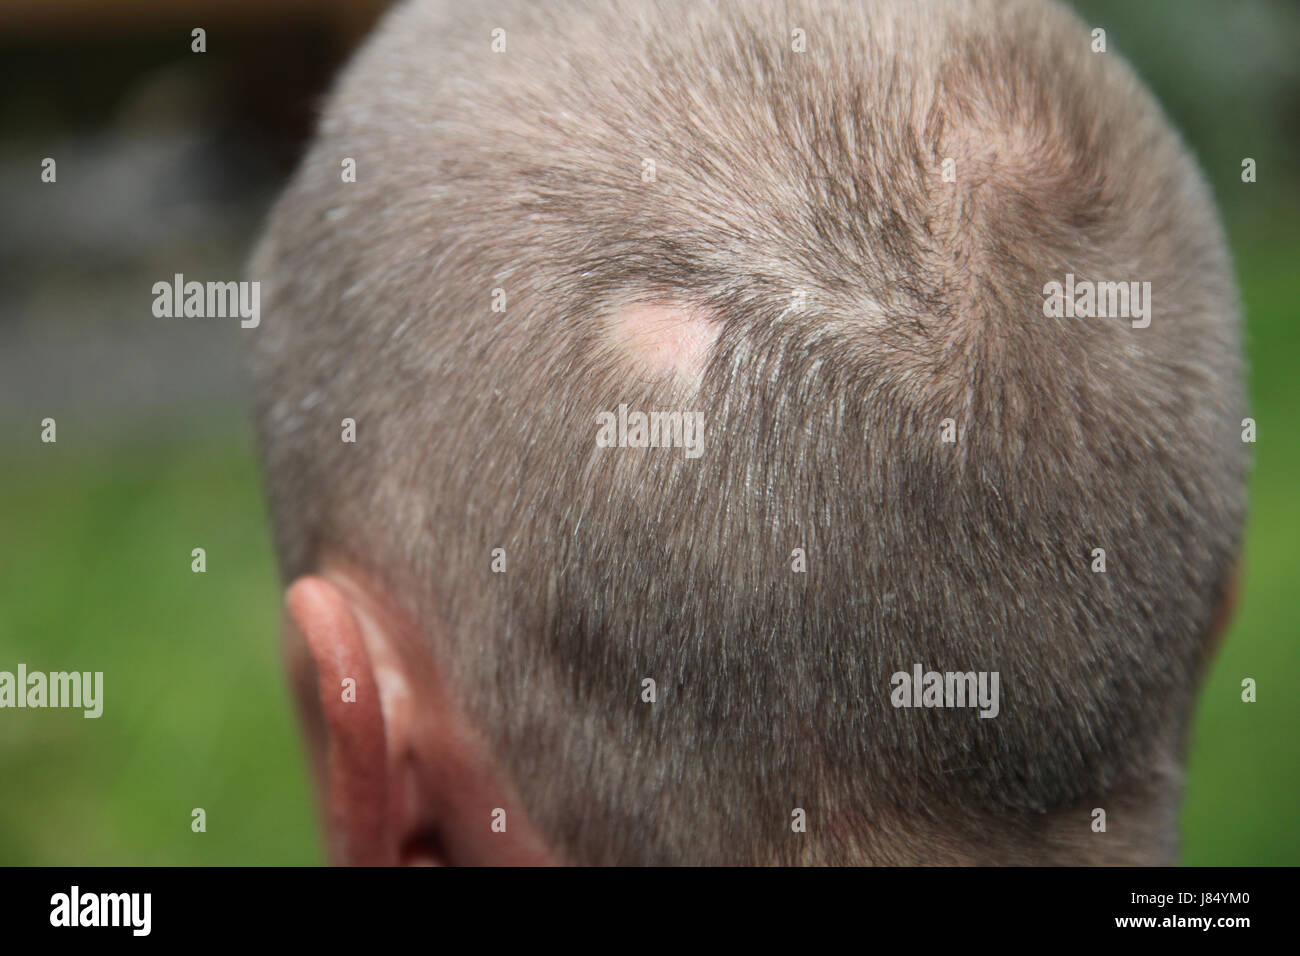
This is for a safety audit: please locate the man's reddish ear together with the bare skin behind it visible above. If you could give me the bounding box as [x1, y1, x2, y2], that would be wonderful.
[285, 571, 553, 866]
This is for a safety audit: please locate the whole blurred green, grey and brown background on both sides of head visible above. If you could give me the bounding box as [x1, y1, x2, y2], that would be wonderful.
[0, 0, 1300, 865]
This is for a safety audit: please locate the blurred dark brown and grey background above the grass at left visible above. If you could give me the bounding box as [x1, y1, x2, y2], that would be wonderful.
[0, 0, 389, 428]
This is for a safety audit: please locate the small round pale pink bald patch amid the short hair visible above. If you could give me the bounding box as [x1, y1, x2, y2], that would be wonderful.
[606, 302, 723, 386]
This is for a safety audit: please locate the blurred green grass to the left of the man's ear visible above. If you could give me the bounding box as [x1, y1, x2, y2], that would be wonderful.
[0, 424, 321, 865]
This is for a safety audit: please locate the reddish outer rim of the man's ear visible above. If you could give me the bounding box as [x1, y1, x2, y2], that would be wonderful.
[285, 576, 398, 866]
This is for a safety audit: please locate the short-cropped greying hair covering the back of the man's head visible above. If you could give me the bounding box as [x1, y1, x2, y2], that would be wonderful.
[250, 0, 1248, 864]
